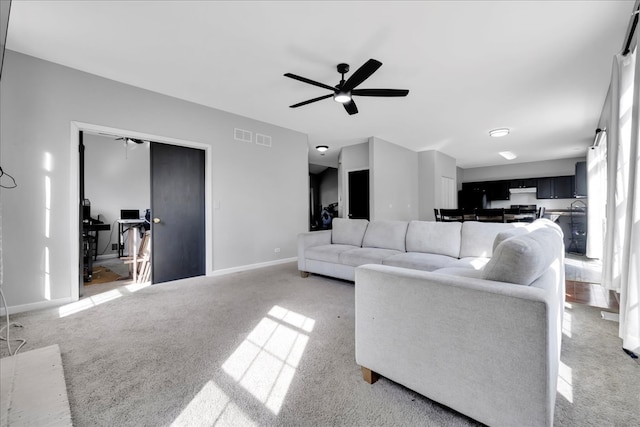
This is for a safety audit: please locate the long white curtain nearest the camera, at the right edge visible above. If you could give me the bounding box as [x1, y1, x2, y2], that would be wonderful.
[602, 51, 640, 352]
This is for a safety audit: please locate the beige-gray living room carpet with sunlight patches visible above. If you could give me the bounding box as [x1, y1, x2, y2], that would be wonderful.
[2, 263, 640, 427]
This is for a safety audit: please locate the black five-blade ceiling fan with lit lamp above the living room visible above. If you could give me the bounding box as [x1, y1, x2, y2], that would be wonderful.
[285, 59, 409, 115]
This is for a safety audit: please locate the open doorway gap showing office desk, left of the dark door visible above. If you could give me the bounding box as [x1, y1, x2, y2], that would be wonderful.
[79, 132, 151, 291]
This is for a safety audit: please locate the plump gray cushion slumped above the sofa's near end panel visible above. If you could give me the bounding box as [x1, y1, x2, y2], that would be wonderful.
[482, 227, 564, 286]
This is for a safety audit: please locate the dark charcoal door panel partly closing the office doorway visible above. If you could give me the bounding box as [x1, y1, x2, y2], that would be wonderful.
[150, 142, 205, 283]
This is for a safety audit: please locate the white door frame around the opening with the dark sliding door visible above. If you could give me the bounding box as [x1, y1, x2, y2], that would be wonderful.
[68, 121, 213, 301]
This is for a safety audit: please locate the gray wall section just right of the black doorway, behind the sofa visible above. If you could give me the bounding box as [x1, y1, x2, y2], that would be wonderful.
[369, 137, 418, 221]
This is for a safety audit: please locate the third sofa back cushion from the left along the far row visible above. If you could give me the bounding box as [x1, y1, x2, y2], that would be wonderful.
[407, 221, 462, 258]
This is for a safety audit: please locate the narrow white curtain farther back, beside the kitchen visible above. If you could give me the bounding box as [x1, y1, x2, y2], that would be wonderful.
[586, 139, 607, 259]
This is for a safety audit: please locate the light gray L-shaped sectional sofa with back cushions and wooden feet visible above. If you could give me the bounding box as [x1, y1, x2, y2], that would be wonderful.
[298, 218, 564, 426]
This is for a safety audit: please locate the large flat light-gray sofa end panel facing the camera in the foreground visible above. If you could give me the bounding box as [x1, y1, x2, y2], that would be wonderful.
[355, 265, 561, 425]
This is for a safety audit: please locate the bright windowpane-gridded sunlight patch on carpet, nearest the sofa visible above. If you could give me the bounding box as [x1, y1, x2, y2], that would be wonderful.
[222, 306, 315, 414]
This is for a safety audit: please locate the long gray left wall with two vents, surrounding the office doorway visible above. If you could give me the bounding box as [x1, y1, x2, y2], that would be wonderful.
[0, 51, 308, 311]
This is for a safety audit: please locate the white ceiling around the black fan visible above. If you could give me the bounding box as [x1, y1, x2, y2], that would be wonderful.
[5, 0, 634, 168]
